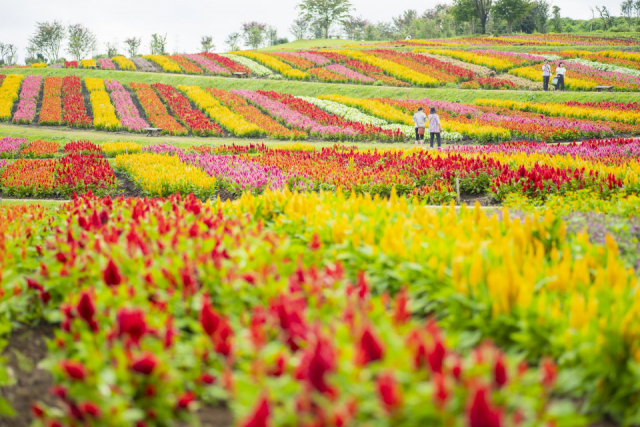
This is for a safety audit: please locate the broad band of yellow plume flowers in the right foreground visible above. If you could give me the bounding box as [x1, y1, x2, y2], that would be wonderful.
[220, 191, 640, 414]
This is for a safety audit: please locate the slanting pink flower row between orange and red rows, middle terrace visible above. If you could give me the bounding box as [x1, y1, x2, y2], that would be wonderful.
[231, 89, 357, 136]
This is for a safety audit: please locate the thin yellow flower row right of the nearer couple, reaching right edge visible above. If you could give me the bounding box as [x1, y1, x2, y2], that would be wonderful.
[473, 98, 640, 124]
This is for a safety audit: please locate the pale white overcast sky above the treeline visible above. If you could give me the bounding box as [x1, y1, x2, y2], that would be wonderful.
[0, 0, 622, 62]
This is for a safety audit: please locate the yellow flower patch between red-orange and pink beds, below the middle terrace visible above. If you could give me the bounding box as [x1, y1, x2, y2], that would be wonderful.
[114, 153, 217, 198]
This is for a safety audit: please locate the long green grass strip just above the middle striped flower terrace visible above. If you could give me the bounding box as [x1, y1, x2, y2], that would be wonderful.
[2, 68, 640, 103]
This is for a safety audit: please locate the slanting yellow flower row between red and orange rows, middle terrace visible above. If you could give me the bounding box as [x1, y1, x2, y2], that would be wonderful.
[178, 85, 265, 137]
